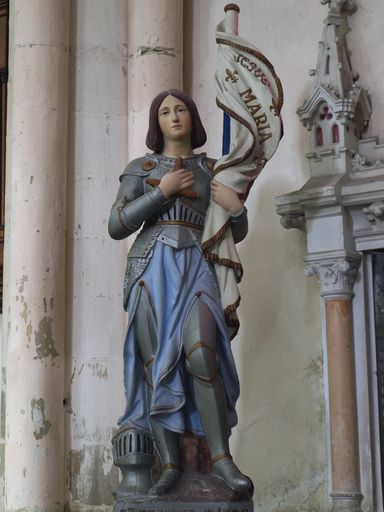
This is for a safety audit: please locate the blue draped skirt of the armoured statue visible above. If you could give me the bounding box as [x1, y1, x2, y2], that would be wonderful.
[119, 241, 239, 435]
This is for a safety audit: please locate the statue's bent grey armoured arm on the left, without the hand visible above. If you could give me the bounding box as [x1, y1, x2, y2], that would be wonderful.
[108, 164, 168, 240]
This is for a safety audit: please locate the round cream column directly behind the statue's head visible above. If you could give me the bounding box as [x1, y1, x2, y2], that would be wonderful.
[128, 0, 183, 160]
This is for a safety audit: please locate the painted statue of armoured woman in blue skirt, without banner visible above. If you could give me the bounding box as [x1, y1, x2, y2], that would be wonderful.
[109, 89, 251, 496]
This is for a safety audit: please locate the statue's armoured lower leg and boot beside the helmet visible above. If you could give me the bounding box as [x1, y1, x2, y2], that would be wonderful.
[148, 418, 183, 496]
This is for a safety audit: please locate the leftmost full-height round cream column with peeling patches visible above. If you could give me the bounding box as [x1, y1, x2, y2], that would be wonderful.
[3, 0, 70, 512]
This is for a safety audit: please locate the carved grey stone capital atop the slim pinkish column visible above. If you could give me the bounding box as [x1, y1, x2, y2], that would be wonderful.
[305, 253, 361, 299]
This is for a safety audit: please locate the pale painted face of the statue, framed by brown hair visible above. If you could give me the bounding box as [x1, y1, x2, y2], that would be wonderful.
[158, 96, 192, 143]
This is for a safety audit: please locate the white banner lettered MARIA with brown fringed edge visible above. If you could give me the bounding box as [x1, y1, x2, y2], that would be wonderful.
[202, 22, 283, 337]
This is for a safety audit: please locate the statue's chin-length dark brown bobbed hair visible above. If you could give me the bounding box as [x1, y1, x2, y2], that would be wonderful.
[146, 89, 207, 153]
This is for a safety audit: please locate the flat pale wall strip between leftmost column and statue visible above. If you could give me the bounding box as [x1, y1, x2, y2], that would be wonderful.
[65, 0, 127, 512]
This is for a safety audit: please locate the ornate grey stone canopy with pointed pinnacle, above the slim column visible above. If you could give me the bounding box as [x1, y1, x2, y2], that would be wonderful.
[276, 0, 384, 258]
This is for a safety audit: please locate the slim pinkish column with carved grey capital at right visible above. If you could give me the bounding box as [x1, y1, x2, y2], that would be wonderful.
[306, 253, 362, 512]
